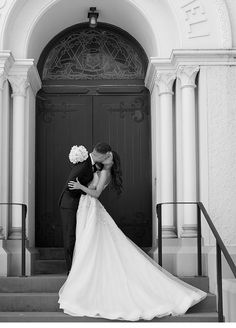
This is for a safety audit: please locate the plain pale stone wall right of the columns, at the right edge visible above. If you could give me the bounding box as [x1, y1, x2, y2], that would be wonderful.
[206, 66, 236, 245]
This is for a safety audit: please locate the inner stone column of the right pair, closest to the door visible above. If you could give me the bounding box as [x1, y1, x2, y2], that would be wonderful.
[156, 71, 176, 238]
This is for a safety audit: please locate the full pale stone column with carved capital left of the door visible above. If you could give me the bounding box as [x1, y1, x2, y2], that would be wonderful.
[9, 75, 29, 239]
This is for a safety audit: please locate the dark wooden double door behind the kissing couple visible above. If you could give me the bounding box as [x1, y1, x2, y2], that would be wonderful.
[35, 92, 152, 247]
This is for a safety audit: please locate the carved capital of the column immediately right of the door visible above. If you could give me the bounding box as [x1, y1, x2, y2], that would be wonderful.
[155, 71, 176, 96]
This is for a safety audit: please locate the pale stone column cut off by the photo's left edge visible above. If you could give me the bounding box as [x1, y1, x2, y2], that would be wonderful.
[0, 70, 6, 239]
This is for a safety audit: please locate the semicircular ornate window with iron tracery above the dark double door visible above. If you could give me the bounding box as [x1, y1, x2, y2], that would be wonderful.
[42, 28, 146, 80]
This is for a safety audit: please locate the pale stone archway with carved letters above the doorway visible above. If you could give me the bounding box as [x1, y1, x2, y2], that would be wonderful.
[0, 0, 232, 62]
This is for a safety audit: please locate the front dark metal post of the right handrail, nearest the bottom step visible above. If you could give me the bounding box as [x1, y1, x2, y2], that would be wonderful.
[216, 241, 224, 322]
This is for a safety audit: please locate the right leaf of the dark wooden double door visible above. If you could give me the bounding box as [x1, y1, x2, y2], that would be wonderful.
[93, 94, 152, 247]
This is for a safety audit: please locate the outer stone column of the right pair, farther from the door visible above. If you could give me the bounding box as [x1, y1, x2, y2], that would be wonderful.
[177, 66, 199, 237]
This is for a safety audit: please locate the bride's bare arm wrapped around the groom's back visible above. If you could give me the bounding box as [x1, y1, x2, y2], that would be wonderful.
[68, 170, 108, 198]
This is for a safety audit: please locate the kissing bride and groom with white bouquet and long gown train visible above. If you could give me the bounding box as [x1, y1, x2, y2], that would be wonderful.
[58, 142, 207, 321]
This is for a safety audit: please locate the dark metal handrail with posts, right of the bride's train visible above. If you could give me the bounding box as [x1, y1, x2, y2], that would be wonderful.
[156, 202, 236, 322]
